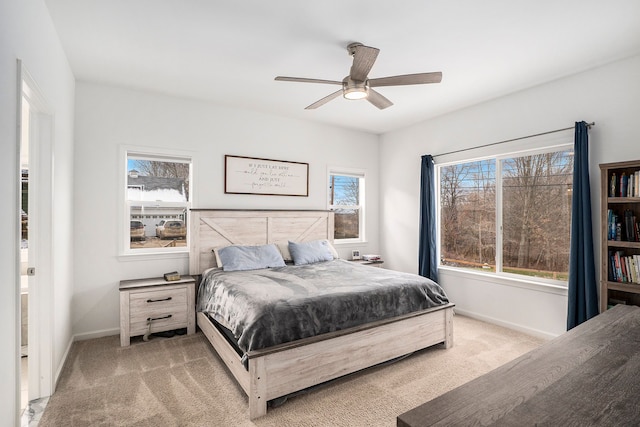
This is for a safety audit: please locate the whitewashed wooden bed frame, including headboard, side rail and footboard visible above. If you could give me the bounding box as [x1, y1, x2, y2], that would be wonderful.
[189, 209, 454, 419]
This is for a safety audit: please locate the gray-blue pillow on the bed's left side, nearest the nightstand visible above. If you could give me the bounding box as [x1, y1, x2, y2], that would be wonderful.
[218, 245, 284, 271]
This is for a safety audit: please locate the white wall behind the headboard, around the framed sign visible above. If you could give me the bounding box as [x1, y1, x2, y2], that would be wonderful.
[73, 83, 379, 337]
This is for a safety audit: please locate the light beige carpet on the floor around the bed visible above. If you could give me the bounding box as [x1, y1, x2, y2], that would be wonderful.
[39, 315, 543, 427]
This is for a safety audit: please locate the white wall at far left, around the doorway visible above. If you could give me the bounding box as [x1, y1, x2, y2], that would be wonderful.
[0, 0, 74, 425]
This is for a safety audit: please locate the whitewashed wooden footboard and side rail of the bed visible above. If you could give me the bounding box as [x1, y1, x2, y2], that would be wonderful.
[198, 304, 454, 419]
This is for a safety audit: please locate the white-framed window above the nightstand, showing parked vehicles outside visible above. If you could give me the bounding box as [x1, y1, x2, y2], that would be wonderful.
[125, 152, 191, 253]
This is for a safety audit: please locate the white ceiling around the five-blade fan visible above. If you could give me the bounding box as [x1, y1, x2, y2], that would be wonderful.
[46, 0, 640, 133]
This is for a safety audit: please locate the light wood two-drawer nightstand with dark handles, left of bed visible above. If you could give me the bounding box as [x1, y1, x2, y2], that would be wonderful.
[120, 276, 196, 347]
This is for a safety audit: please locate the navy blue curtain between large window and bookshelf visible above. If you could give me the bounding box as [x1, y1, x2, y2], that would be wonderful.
[567, 122, 598, 330]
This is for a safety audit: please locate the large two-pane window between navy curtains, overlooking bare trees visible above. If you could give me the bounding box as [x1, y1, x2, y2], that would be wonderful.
[438, 146, 573, 282]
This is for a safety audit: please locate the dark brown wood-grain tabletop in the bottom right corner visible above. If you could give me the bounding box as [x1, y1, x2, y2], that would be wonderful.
[397, 305, 640, 427]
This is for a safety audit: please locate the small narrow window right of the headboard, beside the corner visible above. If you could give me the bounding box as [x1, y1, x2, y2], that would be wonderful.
[329, 170, 365, 243]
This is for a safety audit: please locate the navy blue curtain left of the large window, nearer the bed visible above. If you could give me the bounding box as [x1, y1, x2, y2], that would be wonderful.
[418, 154, 438, 282]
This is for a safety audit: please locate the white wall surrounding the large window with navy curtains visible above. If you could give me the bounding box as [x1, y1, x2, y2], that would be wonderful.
[380, 56, 640, 342]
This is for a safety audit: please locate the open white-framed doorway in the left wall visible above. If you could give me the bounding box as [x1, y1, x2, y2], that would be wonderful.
[16, 61, 53, 419]
